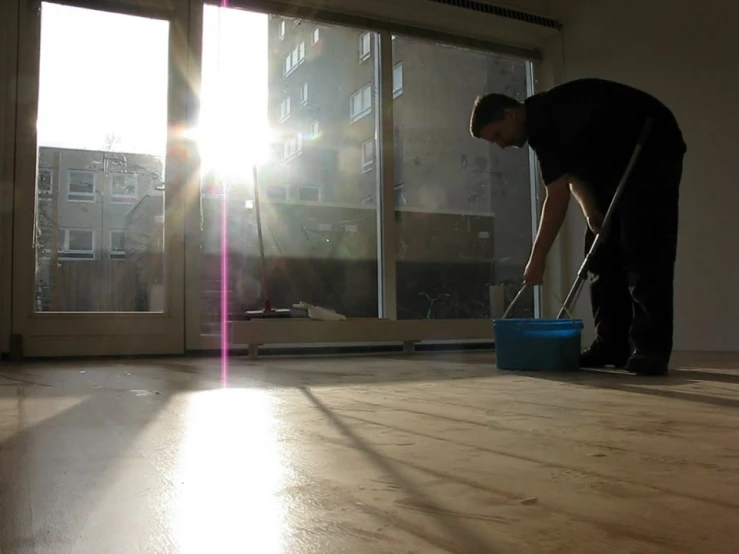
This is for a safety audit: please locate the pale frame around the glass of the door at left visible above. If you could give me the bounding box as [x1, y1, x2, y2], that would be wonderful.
[12, 0, 194, 357]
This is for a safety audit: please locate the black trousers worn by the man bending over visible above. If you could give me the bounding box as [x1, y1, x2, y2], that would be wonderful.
[585, 148, 683, 363]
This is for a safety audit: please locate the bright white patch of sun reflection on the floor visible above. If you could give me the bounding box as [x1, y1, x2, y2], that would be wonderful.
[172, 389, 287, 554]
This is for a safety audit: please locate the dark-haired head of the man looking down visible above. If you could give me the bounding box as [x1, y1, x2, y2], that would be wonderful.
[470, 93, 528, 148]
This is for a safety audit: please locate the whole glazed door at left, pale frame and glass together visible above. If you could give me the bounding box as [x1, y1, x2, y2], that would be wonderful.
[13, 1, 190, 356]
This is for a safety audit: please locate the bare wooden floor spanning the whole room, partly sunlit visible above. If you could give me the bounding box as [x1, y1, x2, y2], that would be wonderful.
[0, 354, 739, 554]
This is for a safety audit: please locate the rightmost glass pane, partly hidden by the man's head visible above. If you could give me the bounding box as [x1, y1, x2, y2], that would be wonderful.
[393, 36, 534, 319]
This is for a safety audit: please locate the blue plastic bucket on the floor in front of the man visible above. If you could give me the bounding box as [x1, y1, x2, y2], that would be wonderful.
[493, 319, 583, 371]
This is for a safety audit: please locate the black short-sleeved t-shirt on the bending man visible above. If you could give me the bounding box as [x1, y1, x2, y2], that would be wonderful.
[525, 79, 686, 188]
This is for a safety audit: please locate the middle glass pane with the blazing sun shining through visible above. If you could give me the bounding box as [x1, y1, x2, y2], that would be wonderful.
[199, 6, 378, 333]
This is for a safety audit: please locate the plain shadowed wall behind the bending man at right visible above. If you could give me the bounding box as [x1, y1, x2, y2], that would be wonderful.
[553, 0, 739, 351]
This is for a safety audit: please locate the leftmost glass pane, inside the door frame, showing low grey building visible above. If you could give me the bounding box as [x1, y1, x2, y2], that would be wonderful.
[36, 2, 169, 312]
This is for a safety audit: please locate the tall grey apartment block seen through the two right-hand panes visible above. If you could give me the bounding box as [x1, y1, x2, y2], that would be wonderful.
[262, 16, 532, 282]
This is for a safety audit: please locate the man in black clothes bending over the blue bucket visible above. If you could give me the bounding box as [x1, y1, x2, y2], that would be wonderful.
[470, 79, 686, 375]
